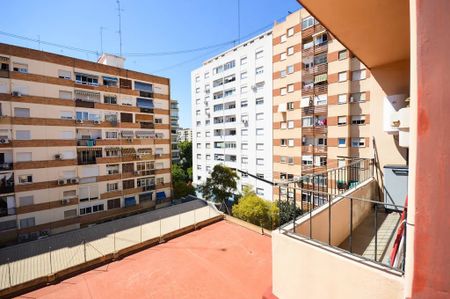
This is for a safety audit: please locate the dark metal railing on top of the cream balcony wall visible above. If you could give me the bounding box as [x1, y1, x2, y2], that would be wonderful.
[279, 160, 406, 272]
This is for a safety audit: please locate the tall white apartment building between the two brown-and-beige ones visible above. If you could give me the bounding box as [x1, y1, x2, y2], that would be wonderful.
[192, 31, 272, 200]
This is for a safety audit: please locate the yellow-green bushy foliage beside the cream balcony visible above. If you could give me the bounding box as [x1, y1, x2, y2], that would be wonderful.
[233, 189, 279, 230]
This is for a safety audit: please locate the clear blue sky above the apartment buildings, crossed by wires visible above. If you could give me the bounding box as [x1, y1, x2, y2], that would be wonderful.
[0, 0, 300, 127]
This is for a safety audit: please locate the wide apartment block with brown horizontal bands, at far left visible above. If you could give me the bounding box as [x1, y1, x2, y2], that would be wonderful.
[0, 44, 171, 246]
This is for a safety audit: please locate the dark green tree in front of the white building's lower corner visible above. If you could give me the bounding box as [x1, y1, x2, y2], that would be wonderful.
[199, 164, 238, 213]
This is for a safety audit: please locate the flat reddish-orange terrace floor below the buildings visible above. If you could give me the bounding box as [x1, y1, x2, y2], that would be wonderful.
[19, 221, 272, 299]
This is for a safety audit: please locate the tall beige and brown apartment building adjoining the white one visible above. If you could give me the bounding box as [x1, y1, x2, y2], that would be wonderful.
[273, 9, 406, 198]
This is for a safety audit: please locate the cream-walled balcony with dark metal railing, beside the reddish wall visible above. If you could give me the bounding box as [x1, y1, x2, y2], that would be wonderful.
[272, 160, 406, 298]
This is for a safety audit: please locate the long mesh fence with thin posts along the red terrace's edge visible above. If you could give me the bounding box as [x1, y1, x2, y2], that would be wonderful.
[0, 201, 221, 290]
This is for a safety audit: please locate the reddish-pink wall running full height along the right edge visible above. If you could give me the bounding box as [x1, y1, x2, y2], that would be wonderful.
[412, 0, 450, 299]
